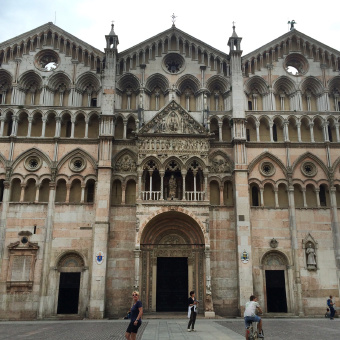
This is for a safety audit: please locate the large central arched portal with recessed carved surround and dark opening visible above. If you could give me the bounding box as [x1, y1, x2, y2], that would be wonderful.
[140, 211, 206, 312]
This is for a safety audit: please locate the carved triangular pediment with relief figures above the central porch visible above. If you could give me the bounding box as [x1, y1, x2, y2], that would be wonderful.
[139, 100, 207, 135]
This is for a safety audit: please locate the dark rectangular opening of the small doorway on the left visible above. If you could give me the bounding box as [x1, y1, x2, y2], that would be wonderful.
[57, 273, 80, 314]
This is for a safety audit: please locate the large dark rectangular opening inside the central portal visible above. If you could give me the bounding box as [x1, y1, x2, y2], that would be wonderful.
[156, 257, 188, 312]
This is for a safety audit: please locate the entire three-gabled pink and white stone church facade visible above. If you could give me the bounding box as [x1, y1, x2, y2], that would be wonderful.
[0, 23, 340, 319]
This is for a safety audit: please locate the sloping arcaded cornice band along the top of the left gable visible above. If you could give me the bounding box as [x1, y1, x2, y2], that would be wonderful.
[0, 22, 104, 56]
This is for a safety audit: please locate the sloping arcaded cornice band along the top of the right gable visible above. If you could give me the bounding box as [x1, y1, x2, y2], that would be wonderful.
[242, 29, 340, 61]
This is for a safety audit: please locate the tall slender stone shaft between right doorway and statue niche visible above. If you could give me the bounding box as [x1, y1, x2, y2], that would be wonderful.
[288, 185, 304, 316]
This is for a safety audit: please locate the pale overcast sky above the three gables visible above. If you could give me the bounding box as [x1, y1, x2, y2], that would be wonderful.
[0, 0, 340, 54]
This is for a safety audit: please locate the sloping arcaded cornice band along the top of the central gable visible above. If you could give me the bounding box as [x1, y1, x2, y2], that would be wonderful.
[119, 26, 229, 59]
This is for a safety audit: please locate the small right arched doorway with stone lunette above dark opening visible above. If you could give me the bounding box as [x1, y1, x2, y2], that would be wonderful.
[262, 251, 290, 313]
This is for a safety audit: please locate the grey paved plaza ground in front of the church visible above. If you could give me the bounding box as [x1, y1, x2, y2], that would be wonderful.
[0, 318, 340, 340]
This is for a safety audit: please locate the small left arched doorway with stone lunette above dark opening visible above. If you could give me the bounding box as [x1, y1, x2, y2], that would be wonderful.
[57, 253, 84, 314]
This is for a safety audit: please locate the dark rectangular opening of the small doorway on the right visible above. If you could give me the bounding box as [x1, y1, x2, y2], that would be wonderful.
[266, 270, 287, 313]
